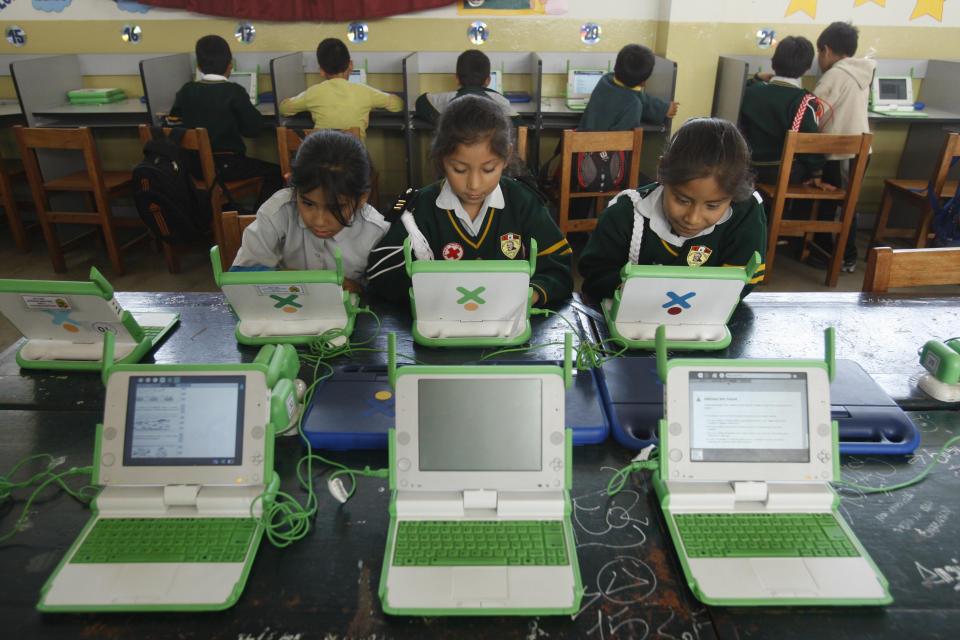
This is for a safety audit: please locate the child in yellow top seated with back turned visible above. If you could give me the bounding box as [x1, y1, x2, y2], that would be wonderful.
[277, 38, 403, 141]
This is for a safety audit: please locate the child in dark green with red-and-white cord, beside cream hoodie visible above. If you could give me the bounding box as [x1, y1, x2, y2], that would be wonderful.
[740, 36, 829, 188]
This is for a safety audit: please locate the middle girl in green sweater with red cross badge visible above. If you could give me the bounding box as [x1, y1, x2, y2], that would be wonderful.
[367, 95, 573, 305]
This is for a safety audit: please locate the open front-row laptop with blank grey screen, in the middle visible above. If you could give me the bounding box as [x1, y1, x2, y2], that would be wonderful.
[380, 335, 583, 615]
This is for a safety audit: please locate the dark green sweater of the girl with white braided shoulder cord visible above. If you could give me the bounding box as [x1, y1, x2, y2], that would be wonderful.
[578, 184, 767, 301]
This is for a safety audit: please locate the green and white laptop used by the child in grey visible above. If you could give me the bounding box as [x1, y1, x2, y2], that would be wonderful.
[210, 246, 358, 345]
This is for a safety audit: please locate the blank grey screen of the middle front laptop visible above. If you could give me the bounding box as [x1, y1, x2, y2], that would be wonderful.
[417, 377, 543, 471]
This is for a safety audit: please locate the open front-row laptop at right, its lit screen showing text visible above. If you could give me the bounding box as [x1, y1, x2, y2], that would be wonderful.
[653, 330, 892, 606]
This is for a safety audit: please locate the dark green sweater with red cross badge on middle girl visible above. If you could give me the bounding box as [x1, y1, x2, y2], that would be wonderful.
[367, 177, 573, 306]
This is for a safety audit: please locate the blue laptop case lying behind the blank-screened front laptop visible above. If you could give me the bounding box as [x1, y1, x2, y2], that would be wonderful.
[302, 361, 610, 451]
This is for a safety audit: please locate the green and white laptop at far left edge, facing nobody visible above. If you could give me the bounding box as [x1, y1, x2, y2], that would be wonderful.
[0, 267, 179, 370]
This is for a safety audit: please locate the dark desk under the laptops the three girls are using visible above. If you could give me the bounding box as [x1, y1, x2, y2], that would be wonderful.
[0, 290, 948, 409]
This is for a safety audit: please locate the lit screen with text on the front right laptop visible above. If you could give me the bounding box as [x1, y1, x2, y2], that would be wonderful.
[689, 370, 810, 462]
